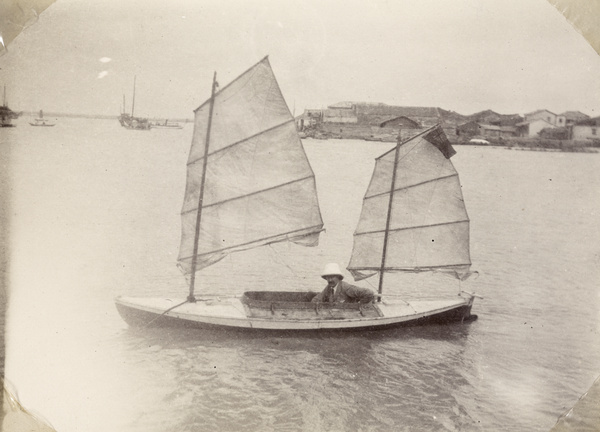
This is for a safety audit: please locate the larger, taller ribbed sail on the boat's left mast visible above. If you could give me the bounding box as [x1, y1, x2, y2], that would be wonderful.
[178, 57, 323, 273]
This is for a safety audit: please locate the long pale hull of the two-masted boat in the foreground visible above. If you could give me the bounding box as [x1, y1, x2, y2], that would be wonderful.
[115, 296, 476, 331]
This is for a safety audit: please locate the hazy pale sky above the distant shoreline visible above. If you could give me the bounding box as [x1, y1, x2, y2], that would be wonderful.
[0, 0, 600, 118]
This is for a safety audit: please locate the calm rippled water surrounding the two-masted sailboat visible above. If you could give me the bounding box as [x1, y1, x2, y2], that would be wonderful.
[0, 119, 600, 432]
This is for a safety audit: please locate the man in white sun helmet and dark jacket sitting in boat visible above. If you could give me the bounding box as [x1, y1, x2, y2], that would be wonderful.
[312, 263, 375, 303]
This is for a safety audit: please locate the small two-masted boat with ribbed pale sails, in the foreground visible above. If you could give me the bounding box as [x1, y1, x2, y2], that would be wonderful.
[115, 57, 474, 331]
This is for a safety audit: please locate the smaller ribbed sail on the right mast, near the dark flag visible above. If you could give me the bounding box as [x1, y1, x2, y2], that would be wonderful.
[348, 125, 471, 280]
